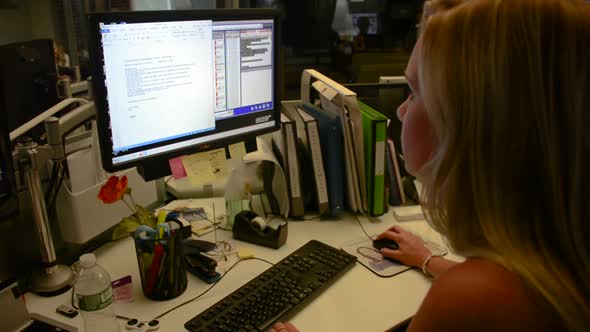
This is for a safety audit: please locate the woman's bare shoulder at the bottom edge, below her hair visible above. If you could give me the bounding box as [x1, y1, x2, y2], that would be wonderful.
[412, 259, 553, 331]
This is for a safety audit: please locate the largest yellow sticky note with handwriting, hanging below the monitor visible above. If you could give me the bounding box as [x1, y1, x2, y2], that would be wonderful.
[182, 148, 227, 186]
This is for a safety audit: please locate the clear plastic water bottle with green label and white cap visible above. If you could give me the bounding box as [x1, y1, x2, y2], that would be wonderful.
[74, 254, 120, 332]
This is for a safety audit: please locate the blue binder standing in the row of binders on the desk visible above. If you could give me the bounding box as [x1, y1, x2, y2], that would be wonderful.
[300, 103, 346, 216]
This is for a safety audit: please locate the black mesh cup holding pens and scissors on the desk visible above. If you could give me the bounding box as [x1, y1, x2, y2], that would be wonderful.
[134, 232, 187, 300]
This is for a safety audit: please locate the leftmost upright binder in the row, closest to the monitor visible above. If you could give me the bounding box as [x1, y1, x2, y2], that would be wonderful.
[272, 113, 305, 218]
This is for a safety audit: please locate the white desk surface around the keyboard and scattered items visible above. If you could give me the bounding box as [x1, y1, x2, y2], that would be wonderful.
[26, 200, 459, 332]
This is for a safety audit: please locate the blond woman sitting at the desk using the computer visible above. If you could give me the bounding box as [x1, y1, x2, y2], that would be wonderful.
[274, 0, 590, 331]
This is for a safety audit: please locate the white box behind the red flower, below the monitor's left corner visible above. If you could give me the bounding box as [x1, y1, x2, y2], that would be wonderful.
[56, 168, 158, 244]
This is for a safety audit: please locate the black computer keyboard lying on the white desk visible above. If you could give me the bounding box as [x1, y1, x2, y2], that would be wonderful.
[184, 240, 356, 332]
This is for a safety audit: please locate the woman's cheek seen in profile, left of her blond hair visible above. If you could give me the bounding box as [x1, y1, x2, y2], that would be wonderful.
[402, 107, 435, 175]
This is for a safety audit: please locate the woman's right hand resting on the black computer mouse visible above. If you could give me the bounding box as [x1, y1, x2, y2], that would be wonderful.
[376, 225, 431, 267]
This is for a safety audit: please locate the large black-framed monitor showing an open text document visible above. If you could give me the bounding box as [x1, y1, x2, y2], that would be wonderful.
[89, 9, 280, 181]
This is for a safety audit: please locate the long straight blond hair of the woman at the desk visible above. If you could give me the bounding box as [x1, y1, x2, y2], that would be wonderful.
[418, 0, 590, 330]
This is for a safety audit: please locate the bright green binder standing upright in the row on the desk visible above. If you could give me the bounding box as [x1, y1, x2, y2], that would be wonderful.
[359, 101, 387, 216]
